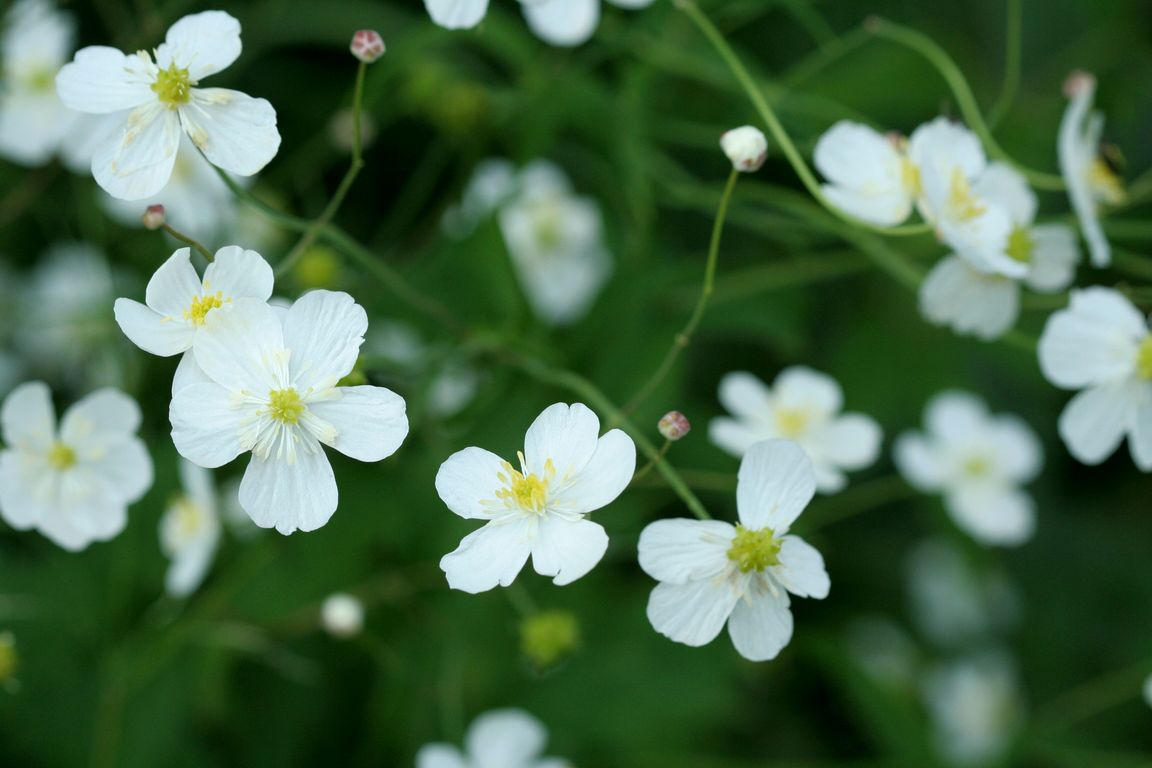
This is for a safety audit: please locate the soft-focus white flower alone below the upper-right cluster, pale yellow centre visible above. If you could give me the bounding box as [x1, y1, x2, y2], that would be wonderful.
[894, 391, 1043, 546]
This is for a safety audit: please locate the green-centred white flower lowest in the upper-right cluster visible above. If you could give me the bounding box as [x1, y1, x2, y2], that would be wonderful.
[920, 162, 1079, 340]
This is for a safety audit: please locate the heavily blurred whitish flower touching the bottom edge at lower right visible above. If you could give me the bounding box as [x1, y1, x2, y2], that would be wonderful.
[924, 652, 1022, 768]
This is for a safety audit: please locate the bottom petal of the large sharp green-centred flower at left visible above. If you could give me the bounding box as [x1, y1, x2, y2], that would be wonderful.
[240, 443, 339, 535]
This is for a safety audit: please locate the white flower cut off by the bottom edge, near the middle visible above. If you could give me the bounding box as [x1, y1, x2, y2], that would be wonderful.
[416, 709, 570, 768]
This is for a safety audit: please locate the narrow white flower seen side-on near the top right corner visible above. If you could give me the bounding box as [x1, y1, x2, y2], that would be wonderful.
[1056, 73, 1124, 267]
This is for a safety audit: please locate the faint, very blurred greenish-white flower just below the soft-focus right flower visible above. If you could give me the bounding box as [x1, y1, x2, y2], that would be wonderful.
[907, 539, 1020, 648]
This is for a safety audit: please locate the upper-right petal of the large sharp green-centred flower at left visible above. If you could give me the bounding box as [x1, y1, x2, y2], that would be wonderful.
[283, 290, 367, 390]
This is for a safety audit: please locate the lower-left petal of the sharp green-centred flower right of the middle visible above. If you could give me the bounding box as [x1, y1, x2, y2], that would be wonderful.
[647, 578, 740, 647]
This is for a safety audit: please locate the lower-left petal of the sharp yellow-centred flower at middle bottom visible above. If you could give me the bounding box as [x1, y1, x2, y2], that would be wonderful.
[440, 517, 536, 594]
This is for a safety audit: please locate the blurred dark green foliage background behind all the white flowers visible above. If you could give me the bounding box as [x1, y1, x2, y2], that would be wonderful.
[0, 0, 1152, 768]
